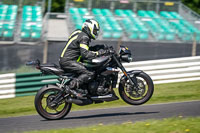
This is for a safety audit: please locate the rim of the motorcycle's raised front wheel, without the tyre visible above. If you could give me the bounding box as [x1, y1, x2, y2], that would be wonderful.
[124, 76, 149, 101]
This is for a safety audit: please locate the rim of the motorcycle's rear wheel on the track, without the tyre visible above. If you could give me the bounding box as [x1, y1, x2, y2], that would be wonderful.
[39, 89, 68, 116]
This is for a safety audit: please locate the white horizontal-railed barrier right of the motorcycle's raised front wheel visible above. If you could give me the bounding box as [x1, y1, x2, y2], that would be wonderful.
[124, 56, 200, 84]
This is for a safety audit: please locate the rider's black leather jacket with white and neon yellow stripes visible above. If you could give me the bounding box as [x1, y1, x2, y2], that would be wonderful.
[60, 30, 98, 62]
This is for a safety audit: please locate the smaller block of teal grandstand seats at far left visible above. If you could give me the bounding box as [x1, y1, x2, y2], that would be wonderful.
[0, 1, 44, 43]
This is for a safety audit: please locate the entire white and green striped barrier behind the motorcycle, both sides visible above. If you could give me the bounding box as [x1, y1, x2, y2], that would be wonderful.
[0, 56, 200, 99]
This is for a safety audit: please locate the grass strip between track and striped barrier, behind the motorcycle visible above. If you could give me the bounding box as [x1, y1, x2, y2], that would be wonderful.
[0, 81, 200, 117]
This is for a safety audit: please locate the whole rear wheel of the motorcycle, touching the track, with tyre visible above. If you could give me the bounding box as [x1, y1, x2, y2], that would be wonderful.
[35, 86, 72, 120]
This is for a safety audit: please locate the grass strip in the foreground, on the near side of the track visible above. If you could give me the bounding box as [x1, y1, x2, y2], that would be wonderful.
[25, 117, 200, 133]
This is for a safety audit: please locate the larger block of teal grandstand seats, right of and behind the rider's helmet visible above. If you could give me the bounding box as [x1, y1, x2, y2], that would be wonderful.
[69, 7, 200, 41]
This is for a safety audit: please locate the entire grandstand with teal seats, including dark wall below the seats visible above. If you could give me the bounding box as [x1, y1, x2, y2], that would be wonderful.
[0, 0, 200, 69]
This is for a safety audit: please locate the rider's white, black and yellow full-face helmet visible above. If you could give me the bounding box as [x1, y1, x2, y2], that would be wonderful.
[82, 19, 100, 40]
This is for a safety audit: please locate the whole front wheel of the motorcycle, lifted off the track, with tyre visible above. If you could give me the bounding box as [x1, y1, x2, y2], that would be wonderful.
[119, 72, 154, 105]
